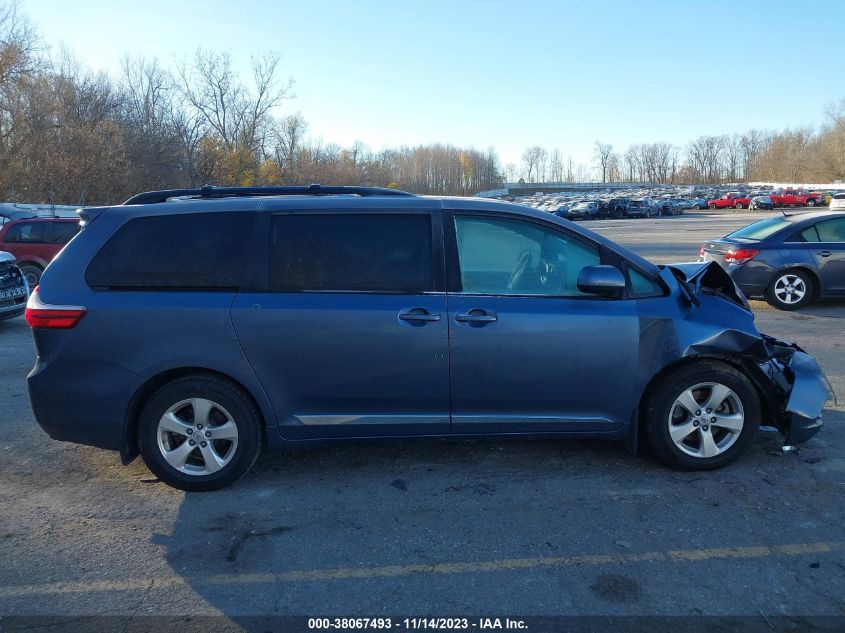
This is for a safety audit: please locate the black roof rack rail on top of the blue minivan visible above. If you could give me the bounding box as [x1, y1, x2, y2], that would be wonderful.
[123, 182, 415, 205]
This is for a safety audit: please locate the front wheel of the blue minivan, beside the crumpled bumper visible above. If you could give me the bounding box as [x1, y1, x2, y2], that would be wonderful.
[644, 360, 761, 470]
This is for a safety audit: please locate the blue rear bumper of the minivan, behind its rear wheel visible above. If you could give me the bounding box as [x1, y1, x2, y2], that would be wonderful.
[27, 359, 140, 450]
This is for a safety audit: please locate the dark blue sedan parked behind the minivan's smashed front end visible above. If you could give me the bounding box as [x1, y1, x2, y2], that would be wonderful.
[700, 212, 845, 310]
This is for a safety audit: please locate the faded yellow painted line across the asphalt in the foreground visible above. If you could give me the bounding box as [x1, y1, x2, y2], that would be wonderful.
[0, 541, 845, 598]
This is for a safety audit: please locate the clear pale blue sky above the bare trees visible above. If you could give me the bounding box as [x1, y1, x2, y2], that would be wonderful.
[21, 0, 845, 168]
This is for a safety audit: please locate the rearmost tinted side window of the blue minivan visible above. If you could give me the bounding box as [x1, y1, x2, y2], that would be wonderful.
[85, 212, 254, 290]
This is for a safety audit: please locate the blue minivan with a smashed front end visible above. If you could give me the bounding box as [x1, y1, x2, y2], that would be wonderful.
[26, 185, 829, 490]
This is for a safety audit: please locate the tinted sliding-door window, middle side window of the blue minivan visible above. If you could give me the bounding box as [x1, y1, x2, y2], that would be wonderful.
[270, 213, 433, 293]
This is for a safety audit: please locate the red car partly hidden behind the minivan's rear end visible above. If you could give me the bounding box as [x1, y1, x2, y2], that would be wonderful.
[0, 217, 79, 288]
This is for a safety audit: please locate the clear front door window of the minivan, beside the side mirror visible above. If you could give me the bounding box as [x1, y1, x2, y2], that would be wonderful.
[455, 216, 601, 297]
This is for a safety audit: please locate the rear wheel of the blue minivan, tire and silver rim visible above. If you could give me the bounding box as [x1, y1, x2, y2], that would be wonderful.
[138, 374, 262, 492]
